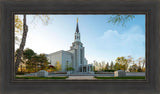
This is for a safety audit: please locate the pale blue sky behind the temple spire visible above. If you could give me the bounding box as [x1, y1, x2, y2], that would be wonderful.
[15, 15, 145, 63]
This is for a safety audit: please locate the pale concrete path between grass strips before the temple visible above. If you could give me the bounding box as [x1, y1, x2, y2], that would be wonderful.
[66, 76, 96, 80]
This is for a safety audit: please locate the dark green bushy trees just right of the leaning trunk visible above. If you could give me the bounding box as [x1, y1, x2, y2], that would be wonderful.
[16, 48, 50, 73]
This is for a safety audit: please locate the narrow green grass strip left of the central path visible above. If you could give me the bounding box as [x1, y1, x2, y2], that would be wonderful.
[16, 77, 68, 79]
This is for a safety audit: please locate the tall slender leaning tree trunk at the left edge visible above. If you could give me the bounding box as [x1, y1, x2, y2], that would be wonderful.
[15, 14, 28, 72]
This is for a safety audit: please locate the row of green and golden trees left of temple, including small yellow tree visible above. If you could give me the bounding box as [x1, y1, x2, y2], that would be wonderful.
[15, 48, 61, 73]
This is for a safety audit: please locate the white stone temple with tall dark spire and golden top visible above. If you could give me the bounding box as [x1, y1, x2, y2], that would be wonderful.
[46, 18, 92, 72]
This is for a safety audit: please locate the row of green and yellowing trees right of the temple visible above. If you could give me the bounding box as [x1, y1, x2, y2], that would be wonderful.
[93, 56, 145, 72]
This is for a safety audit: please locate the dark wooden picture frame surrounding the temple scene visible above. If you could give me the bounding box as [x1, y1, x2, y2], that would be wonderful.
[0, 0, 160, 94]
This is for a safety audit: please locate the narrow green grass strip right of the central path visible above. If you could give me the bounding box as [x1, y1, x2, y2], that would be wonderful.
[95, 76, 145, 79]
